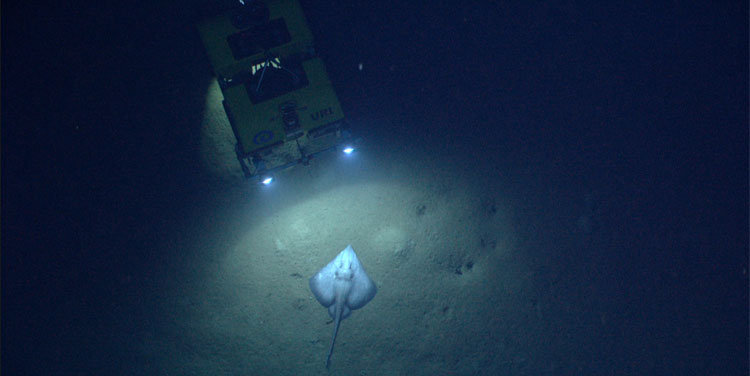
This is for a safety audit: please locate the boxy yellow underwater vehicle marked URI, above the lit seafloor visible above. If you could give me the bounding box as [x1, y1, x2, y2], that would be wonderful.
[198, 0, 350, 178]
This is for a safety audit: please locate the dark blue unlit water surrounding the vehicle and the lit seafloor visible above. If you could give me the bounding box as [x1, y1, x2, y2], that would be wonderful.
[1, 0, 748, 375]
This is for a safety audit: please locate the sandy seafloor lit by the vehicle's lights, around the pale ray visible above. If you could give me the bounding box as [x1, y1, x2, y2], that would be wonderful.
[111, 81, 636, 375]
